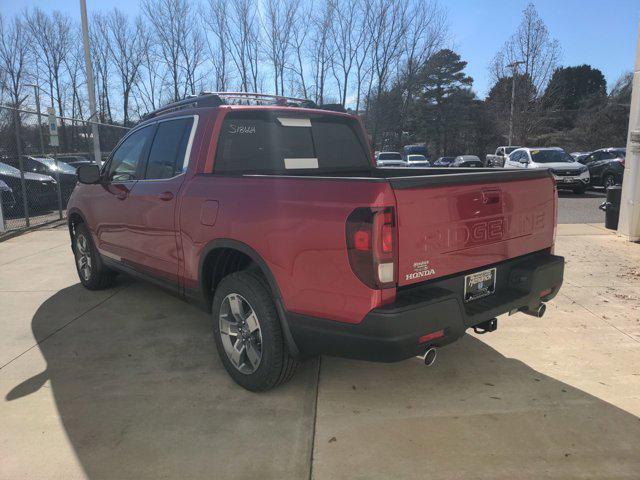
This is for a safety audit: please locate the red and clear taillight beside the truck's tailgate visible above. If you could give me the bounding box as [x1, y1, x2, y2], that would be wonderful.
[346, 207, 396, 289]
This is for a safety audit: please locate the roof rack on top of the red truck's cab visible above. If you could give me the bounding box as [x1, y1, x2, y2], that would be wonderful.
[142, 92, 318, 120]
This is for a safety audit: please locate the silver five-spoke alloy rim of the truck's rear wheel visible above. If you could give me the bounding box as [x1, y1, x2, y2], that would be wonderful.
[218, 293, 262, 375]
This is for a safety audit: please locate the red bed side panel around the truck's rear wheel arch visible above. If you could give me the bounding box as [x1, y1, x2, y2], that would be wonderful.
[180, 175, 395, 323]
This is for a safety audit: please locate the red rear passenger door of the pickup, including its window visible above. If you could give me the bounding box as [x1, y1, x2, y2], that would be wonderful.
[128, 115, 198, 285]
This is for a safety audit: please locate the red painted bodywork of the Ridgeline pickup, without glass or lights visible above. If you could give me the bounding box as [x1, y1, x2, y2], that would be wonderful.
[69, 106, 556, 323]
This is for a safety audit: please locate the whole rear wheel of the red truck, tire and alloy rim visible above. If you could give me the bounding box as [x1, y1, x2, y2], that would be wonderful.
[212, 271, 298, 392]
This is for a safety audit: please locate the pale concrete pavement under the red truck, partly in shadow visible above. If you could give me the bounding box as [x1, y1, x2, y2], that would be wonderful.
[0, 225, 640, 480]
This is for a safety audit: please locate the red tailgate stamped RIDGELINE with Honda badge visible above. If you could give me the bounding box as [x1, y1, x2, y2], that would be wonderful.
[391, 174, 556, 286]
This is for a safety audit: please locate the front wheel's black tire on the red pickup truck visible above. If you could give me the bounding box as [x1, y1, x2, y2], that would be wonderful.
[73, 223, 116, 290]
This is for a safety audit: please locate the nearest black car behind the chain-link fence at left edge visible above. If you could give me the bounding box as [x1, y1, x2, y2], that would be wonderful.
[0, 163, 58, 215]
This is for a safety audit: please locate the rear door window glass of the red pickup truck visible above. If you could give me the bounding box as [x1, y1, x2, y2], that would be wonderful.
[145, 117, 193, 180]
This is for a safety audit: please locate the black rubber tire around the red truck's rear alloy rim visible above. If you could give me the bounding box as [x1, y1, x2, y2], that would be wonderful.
[212, 270, 299, 392]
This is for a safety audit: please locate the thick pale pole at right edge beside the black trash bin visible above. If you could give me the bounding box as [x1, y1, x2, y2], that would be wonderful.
[618, 22, 640, 242]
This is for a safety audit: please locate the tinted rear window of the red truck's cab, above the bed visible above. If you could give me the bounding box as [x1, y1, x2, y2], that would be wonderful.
[214, 111, 371, 173]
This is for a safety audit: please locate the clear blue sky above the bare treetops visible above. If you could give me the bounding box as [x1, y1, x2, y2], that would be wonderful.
[5, 0, 640, 97]
